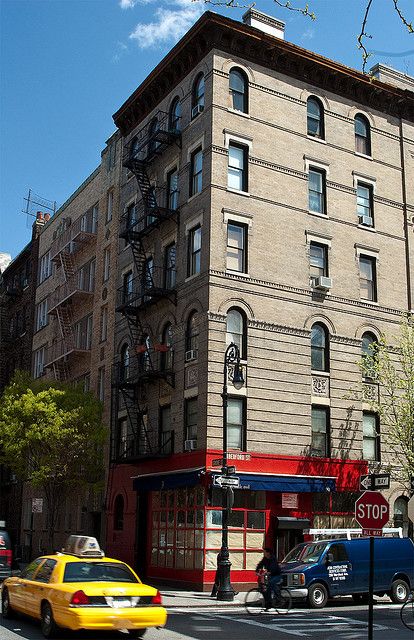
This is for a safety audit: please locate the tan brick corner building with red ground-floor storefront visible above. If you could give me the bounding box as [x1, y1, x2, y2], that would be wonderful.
[106, 10, 414, 589]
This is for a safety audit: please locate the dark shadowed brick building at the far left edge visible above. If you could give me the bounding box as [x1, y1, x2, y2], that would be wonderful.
[0, 213, 43, 547]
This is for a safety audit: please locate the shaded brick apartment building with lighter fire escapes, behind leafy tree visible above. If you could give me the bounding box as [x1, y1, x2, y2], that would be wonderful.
[22, 133, 121, 555]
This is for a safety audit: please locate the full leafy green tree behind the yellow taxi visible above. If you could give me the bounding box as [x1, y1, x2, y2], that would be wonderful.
[0, 371, 106, 549]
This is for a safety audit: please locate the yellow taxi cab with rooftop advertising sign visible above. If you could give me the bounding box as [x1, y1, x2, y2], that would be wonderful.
[1, 536, 167, 638]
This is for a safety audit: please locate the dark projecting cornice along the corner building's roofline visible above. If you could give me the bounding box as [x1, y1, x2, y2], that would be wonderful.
[113, 11, 414, 136]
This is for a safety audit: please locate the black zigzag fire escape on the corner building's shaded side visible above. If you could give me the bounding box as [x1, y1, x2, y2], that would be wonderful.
[112, 112, 181, 462]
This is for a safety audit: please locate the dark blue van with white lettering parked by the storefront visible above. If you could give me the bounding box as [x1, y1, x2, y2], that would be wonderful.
[280, 538, 414, 609]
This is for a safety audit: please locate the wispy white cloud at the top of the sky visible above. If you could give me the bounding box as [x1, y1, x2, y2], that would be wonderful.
[129, 0, 204, 49]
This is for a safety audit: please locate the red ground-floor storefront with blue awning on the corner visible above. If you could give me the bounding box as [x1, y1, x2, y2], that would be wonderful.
[105, 450, 367, 589]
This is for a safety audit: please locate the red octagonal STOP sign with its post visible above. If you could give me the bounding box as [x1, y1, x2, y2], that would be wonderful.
[355, 491, 390, 640]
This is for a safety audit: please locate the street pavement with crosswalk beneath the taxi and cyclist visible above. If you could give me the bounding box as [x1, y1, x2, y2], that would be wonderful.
[0, 588, 413, 640]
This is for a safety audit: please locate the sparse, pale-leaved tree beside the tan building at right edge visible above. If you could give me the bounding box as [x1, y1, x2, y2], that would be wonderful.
[361, 318, 414, 490]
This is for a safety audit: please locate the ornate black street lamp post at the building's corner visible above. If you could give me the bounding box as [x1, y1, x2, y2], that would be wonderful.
[217, 344, 234, 602]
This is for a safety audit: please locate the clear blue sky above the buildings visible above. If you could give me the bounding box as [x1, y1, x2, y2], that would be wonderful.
[0, 0, 414, 257]
